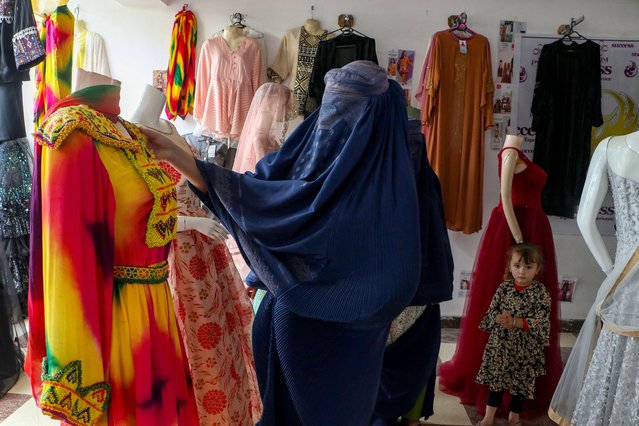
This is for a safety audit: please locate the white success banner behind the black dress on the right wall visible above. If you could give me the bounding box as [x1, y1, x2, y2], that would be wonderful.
[510, 34, 639, 235]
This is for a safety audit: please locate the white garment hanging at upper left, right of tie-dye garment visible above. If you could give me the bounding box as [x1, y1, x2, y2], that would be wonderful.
[73, 21, 111, 78]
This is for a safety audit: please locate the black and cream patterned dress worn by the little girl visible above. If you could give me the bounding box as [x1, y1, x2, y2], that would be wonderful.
[477, 280, 550, 399]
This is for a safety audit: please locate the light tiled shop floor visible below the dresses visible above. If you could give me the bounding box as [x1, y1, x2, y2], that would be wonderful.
[0, 328, 575, 426]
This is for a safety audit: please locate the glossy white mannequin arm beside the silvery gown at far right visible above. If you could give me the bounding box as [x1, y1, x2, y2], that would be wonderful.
[577, 140, 614, 274]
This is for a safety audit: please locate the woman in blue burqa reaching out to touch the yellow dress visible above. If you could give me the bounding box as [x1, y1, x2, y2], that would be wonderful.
[144, 61, 452, 426]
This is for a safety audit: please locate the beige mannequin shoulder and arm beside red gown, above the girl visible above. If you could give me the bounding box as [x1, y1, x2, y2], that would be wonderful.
[500, 135, 528, 243]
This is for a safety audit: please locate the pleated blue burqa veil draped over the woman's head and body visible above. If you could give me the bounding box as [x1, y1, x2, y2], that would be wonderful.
[196, 61, 421, 322]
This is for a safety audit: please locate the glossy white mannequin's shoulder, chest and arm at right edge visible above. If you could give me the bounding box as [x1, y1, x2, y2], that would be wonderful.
[577, 132, 639, 274]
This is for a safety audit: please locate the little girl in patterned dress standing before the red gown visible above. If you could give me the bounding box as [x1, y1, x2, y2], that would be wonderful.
[477, 243, 550, 426]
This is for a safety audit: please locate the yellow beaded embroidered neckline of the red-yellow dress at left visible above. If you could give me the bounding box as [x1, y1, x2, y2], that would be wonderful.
[33, 105, 177, 247]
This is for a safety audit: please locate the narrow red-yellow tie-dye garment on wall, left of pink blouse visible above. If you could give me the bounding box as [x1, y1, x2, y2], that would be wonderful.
[165, 6, 197, 120]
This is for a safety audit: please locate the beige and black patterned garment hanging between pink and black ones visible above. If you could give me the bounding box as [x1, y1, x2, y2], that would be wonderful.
[269, 26, 328, 115]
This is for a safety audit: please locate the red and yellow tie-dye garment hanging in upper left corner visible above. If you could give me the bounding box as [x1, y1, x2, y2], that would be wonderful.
[33, 5, 75, 129]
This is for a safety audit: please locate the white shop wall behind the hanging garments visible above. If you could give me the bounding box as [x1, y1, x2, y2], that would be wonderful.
[25, 0, 639, 319]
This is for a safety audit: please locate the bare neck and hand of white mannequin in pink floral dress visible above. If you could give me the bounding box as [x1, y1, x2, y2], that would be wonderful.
[130, 85, 228, 241]
